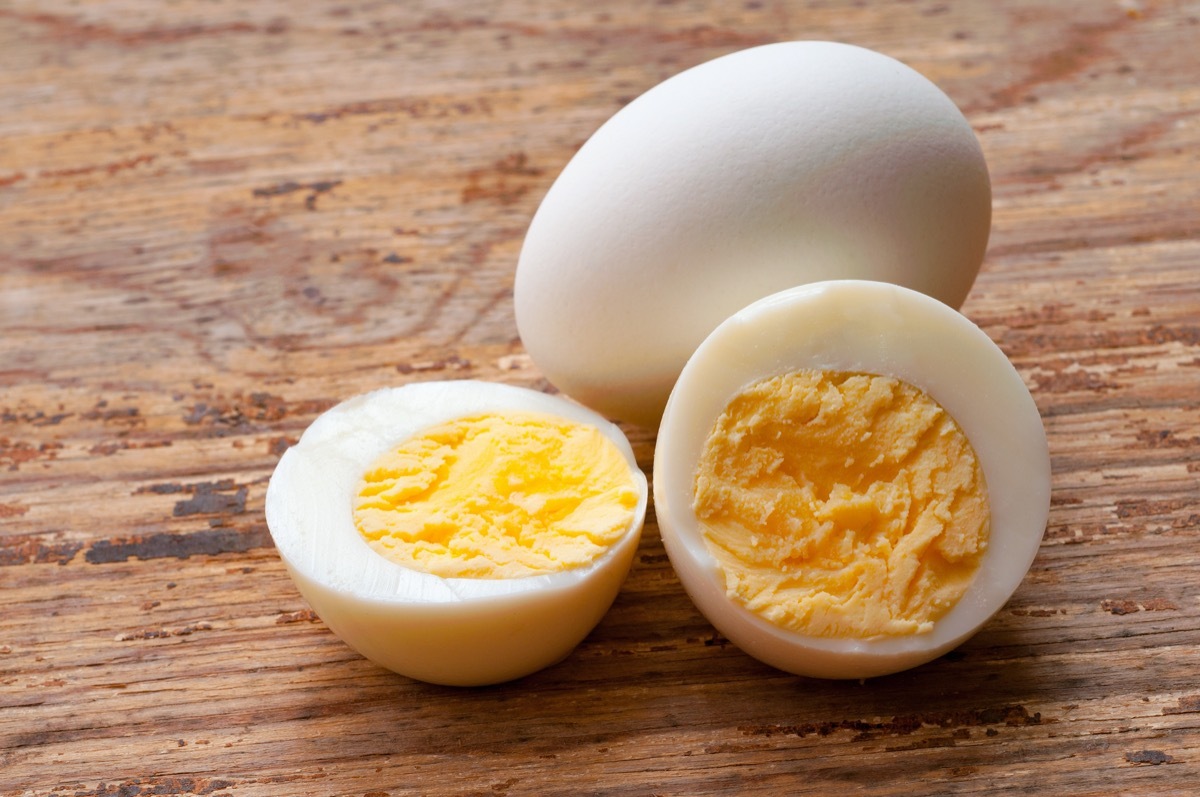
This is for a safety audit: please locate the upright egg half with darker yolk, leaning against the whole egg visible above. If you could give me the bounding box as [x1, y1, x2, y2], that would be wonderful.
[654, 280, 1050, 678]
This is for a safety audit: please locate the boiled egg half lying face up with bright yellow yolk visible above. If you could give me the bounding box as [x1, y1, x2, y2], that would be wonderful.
[266, 380, 648, 685]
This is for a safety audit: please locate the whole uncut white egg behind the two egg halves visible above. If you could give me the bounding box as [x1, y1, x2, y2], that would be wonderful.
[515, 41, 991, 426]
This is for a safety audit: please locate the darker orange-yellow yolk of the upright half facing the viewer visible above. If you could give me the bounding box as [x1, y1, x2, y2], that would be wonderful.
[694, 370, 990, 639]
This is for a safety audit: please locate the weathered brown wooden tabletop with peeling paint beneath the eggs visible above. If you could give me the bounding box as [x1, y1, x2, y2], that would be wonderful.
[0, 0, 1200, 797]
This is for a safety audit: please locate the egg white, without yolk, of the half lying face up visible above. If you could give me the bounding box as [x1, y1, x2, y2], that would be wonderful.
[266, 380, 648, 687]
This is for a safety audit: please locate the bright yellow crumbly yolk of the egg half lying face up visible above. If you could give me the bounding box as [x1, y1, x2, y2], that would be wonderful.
[354, 414, 638, 579]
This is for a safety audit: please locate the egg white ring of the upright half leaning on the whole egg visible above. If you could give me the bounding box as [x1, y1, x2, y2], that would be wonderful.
[653, 280, 1050, 678]
